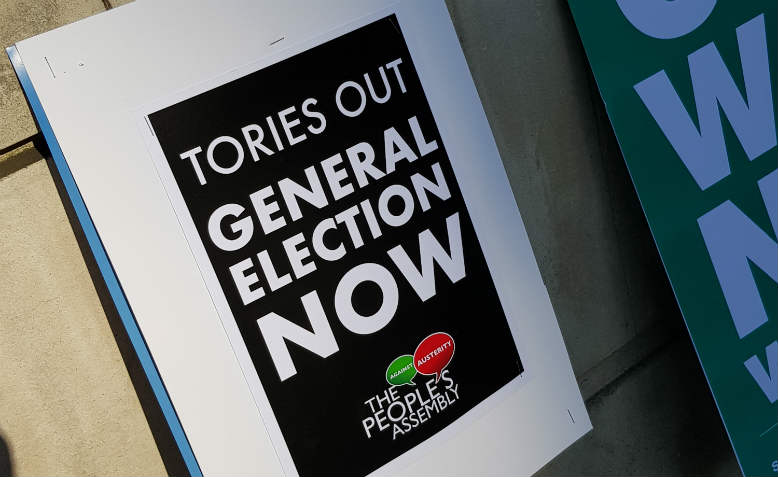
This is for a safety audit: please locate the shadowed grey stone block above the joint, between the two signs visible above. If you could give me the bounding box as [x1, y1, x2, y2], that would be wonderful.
[448, 0, 677, 376]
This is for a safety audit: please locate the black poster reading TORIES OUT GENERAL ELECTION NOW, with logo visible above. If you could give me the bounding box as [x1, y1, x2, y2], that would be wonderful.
[149, 15, 523, 475]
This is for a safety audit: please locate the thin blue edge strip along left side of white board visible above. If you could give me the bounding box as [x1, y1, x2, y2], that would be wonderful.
[6, 46, 203, 477]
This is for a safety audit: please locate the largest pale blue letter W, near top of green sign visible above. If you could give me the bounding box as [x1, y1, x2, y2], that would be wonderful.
[635, 15, 776, 190]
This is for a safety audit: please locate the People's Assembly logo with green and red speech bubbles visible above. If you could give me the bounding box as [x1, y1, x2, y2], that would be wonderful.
[362, 332, 459, 440]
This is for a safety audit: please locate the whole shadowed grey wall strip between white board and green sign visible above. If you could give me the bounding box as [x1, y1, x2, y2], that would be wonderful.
[447, 0, 739, 475]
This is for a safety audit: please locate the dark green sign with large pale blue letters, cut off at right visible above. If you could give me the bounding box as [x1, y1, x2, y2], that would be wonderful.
[569, 0, 778, 475]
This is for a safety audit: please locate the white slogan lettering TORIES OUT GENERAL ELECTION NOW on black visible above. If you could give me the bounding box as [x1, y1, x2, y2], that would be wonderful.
[173, 59, 465, 381]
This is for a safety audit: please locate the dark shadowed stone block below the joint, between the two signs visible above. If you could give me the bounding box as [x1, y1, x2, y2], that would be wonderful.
[536, 335, 740, 477]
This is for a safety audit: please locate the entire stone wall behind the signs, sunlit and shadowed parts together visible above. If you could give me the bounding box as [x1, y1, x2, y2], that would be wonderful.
[0, 0, 738, 475]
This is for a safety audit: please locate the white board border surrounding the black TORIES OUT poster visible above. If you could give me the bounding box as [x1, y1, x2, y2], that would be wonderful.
[10, 1, 591, 475]
